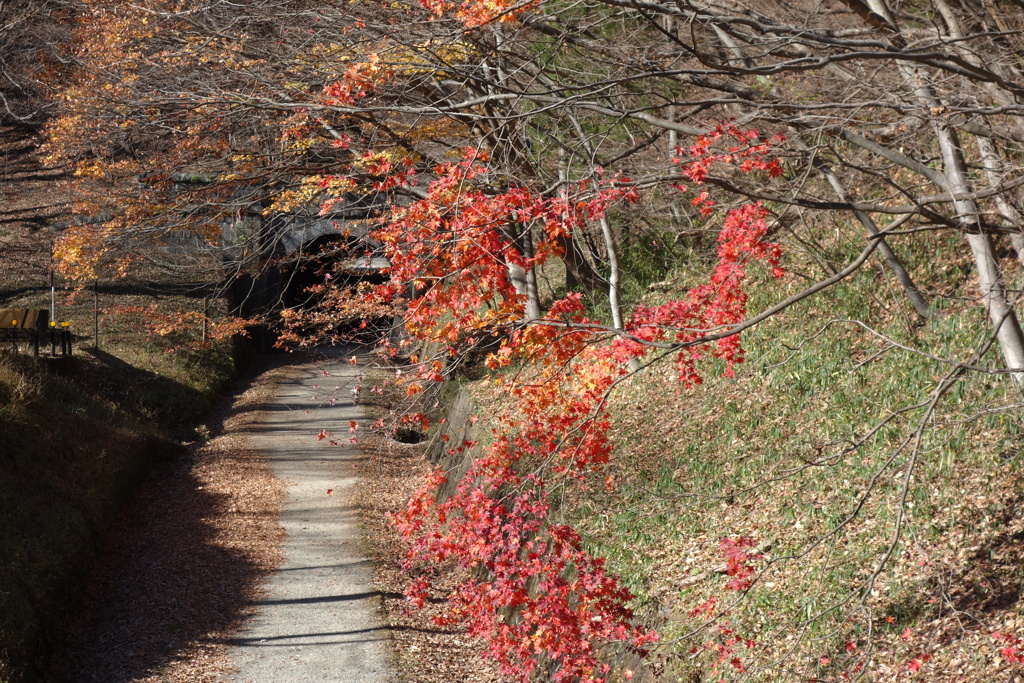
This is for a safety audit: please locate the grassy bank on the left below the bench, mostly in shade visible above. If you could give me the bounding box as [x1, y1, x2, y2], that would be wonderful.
[0, 321, 232, 680]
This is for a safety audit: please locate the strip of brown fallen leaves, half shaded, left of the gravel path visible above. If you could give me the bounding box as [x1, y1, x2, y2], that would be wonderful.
[30, 358, 283, 683]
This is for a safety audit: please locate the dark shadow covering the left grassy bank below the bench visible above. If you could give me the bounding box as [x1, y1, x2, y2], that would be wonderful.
[0, 352, 208, 680]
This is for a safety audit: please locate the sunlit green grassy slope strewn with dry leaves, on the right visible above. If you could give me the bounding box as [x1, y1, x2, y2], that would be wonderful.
[567, 228, 1024, 681]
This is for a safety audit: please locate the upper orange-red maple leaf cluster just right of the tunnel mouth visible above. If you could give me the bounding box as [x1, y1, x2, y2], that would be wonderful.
[375, 147, 636, 352]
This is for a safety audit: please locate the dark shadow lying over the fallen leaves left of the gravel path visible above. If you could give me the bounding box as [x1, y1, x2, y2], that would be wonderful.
[44, 452, 265, 683]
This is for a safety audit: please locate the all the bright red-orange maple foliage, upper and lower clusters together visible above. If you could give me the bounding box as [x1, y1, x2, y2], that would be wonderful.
[356, 121, 781, 681]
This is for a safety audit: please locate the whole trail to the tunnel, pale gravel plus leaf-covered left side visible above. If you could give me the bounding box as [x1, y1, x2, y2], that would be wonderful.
[48, 349, 396, 683]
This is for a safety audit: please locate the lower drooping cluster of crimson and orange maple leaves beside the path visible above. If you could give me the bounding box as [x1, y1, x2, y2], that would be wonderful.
[396, 329, 656, 681]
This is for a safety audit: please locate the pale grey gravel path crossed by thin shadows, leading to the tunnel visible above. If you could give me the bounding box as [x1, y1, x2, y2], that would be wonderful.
[228, 350, 396, 683]
